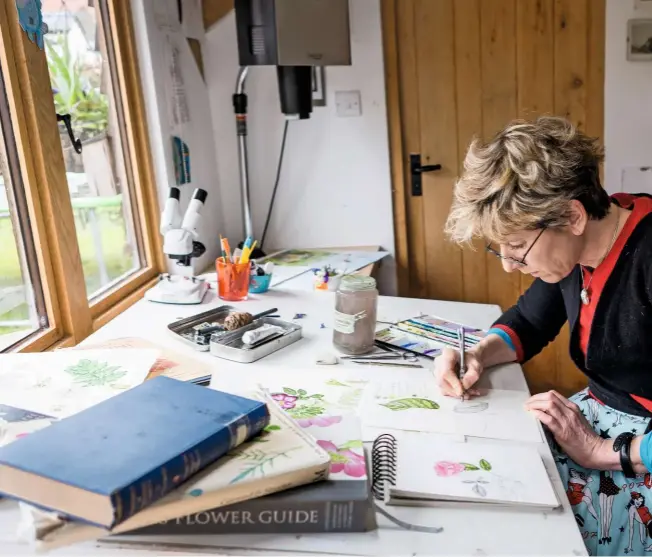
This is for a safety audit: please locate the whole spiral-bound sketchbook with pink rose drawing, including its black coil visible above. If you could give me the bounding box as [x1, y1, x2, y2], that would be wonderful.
[371, 432, 560, 510]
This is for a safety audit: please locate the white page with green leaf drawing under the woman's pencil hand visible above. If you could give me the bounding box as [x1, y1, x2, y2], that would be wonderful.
[360, 379, 541, 443]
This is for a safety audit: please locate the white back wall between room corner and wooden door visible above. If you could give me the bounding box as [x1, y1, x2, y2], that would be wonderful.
[204, 0, 396, 294]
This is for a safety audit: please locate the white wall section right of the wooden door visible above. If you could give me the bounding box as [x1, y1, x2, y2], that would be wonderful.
[604, 0, 652, 193]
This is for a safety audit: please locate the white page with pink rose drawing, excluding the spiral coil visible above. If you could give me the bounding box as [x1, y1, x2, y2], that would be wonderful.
[391, 433, 559, 508]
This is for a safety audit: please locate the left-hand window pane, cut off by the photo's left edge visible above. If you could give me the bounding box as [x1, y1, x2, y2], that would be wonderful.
[0, 68, 48, 350]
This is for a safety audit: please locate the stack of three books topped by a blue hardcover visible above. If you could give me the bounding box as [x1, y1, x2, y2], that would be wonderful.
[0, 340, 374, 550]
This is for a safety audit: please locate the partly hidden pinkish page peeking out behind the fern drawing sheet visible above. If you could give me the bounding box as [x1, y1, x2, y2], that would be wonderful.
[72, 337, 213, 381]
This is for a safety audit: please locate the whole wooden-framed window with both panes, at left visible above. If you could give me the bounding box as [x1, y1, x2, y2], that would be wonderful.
[0, 0, 165, 351]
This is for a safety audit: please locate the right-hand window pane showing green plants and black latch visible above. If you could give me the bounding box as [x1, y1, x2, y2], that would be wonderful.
[43, 0, 144, 299]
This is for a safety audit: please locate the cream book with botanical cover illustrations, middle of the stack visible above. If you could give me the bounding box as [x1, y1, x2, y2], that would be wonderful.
[32, 392, 334, 549]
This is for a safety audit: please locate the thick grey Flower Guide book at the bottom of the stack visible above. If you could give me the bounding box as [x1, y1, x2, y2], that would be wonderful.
[114, 414, 375, 543]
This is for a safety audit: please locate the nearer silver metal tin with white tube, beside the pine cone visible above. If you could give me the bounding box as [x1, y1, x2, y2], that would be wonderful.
[210, 317, 302, 364]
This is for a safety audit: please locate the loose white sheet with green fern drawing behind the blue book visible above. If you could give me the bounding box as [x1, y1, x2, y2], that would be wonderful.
[0, 348, 159, 419]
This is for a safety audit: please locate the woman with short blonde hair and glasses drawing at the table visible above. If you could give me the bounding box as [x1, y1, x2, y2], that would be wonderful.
[435, 117, 652, 555]
